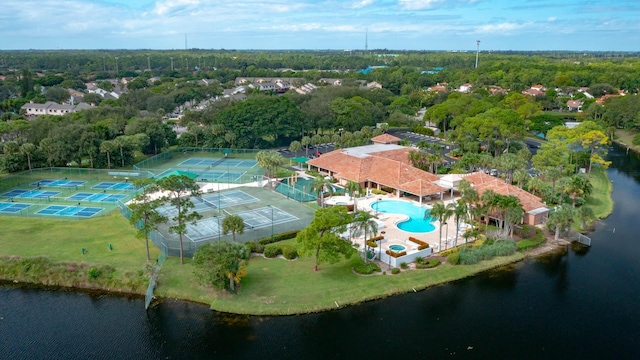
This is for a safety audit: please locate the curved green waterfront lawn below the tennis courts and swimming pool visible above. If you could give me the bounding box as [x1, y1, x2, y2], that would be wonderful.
[156, 242, 524, 315]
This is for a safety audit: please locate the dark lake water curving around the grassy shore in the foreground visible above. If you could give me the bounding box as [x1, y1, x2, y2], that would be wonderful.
[0, 144, 640, 359]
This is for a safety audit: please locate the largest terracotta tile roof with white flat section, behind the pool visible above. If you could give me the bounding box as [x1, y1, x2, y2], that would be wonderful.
[307, 145, 446, 195]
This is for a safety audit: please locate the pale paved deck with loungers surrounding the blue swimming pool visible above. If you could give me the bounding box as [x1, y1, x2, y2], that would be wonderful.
[338, 195, 466, 253]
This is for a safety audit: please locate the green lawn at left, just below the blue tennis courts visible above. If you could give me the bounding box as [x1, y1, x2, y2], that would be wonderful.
[0, 211, 159, 278]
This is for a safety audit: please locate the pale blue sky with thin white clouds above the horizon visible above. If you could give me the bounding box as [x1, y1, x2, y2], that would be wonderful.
[0, 0, 640, 51]
